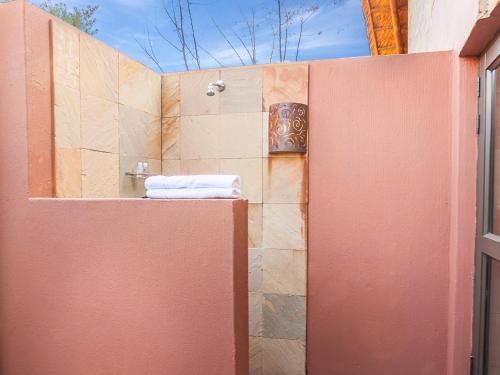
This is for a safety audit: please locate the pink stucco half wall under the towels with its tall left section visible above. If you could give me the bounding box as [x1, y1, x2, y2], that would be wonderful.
[0, 2, 248, 375]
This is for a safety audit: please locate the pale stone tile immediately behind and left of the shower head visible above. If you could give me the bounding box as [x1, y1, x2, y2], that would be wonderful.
[181, 70, 221, 116]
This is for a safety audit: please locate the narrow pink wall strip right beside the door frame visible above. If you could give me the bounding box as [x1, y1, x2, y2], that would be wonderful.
[447, 57, 478, 375]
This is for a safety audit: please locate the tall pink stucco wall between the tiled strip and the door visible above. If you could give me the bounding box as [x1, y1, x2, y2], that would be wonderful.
[307, 52, 476, 375]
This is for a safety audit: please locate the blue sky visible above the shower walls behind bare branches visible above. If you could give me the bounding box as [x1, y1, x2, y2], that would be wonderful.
[33, 0, 369, 72]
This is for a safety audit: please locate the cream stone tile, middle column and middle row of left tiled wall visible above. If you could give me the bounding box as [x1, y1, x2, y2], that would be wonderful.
[81, 96, 120, 154]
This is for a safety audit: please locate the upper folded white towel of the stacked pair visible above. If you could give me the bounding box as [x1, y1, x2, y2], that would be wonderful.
[144, 175, 240, 190]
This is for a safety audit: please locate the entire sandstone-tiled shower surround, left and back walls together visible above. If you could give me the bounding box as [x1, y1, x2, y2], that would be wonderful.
[52, 22, 308, 375]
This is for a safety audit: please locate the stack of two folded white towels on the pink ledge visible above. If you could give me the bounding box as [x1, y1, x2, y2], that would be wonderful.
[144, 175, 241, 199]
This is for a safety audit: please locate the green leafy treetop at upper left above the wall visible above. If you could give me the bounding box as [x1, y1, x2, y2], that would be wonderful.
[40, 0, 99, 35]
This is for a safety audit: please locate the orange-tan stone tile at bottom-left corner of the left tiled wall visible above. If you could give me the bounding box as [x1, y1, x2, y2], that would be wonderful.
[55, 148, 82, 198]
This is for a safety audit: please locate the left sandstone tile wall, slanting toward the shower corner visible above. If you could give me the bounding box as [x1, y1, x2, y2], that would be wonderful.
[51, 21, 162, 198]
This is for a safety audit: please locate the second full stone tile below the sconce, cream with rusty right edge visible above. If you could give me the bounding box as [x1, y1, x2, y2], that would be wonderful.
[262, 204, 307, 250]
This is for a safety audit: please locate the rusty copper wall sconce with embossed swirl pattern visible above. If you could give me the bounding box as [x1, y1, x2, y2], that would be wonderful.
[269, 103, 309, 154]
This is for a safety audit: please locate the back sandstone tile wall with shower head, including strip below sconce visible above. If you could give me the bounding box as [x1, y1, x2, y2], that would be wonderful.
[162, 64, 308, 375]
